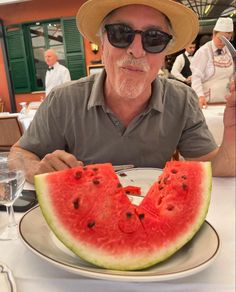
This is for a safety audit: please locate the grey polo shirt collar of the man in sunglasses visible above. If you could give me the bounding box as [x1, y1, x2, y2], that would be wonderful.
[87, 70, 164, 113]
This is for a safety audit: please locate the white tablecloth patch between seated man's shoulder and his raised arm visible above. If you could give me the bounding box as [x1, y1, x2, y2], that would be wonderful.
[202, 105, 225, 145]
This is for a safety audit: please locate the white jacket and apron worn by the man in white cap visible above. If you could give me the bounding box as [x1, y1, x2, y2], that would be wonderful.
[190, 41, 234, 102]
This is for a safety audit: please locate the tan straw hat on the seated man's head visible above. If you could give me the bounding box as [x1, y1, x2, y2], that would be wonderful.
[76, 0, 199, 54]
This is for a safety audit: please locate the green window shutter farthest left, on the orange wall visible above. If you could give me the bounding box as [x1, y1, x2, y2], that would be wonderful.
[6, 25, 31, 93]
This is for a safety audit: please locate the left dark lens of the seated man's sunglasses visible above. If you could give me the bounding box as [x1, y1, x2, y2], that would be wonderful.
[105, 24, 135, 48]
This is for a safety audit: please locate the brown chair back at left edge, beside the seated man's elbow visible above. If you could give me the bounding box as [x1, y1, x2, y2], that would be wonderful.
[0, 116, 23, 151]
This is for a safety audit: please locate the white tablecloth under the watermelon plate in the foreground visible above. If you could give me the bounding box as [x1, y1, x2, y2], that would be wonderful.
[0, 178, 235, 292]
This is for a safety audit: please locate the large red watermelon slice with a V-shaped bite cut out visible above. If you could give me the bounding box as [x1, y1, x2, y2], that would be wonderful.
[35, 161, 211, 270]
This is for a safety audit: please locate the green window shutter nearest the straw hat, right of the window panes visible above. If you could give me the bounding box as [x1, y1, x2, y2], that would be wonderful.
[62, 18, 86, 80]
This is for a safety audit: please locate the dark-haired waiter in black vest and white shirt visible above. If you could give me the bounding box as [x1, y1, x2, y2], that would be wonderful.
[171, 41, 196, 85]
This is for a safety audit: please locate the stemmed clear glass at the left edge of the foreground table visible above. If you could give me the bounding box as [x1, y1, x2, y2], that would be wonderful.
[0, 152, 25, 240]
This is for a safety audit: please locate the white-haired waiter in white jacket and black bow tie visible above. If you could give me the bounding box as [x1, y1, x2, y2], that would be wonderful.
[44, 49, 71, 96]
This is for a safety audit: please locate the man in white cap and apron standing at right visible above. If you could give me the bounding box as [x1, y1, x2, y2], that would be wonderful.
[191, 17, 234, 108]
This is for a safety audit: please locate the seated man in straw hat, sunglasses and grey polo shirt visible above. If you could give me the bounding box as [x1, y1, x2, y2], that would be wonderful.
[10, 0, 235, 182]
